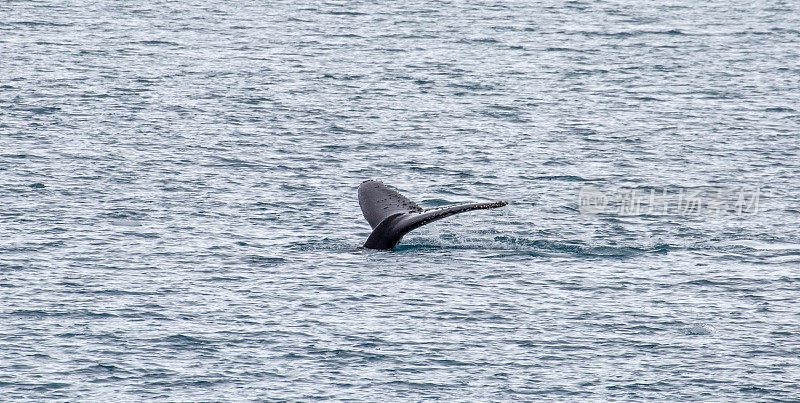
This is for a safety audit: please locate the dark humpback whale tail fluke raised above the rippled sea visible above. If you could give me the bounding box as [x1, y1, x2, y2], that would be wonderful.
[358, 180, 508, 250]
